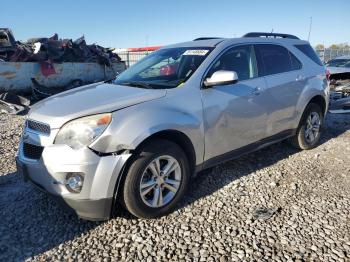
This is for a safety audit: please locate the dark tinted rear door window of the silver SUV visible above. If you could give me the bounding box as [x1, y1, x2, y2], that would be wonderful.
[255, 44, 301, 76]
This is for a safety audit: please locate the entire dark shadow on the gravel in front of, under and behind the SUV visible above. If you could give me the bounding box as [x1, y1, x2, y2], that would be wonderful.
[0, 112, 350, 261]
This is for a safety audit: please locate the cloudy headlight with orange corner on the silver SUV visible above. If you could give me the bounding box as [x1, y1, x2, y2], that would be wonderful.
[55, 113, 112, 149]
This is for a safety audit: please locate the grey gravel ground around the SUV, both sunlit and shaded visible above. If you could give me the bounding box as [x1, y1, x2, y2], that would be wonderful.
[0, 115, 350, 261]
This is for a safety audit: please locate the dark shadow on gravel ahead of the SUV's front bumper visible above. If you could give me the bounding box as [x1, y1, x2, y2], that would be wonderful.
[0, 172, 103, 261]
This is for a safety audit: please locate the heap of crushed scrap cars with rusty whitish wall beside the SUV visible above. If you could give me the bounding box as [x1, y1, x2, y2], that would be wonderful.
[0, 28, 126, 114]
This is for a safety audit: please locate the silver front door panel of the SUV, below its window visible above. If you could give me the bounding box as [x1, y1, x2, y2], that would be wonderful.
[202, 78, 268, 160]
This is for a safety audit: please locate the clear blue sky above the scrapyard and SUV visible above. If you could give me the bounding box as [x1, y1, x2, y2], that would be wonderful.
[0, 0, 350, 48]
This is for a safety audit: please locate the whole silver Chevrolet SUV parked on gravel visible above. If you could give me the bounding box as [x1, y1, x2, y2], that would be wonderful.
[16, 33, 329, 220]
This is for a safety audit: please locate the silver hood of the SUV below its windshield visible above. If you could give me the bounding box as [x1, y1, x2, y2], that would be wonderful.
[28, 83, 166, 128]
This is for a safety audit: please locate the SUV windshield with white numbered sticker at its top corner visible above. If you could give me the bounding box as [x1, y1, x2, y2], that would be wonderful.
[114, 47, 212, 89]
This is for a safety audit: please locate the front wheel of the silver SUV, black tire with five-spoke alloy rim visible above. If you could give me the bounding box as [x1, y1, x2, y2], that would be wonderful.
[122, 139, 190, 218]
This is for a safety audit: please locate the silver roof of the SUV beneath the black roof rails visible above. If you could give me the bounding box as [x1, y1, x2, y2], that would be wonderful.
[163, 37, 309, 48]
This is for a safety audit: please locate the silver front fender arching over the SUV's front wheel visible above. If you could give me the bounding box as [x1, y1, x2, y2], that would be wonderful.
[90, 101, 204, 164]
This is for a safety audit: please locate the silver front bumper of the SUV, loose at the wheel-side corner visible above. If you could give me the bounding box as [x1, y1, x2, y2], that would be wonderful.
[16, 132, 131, 220]
